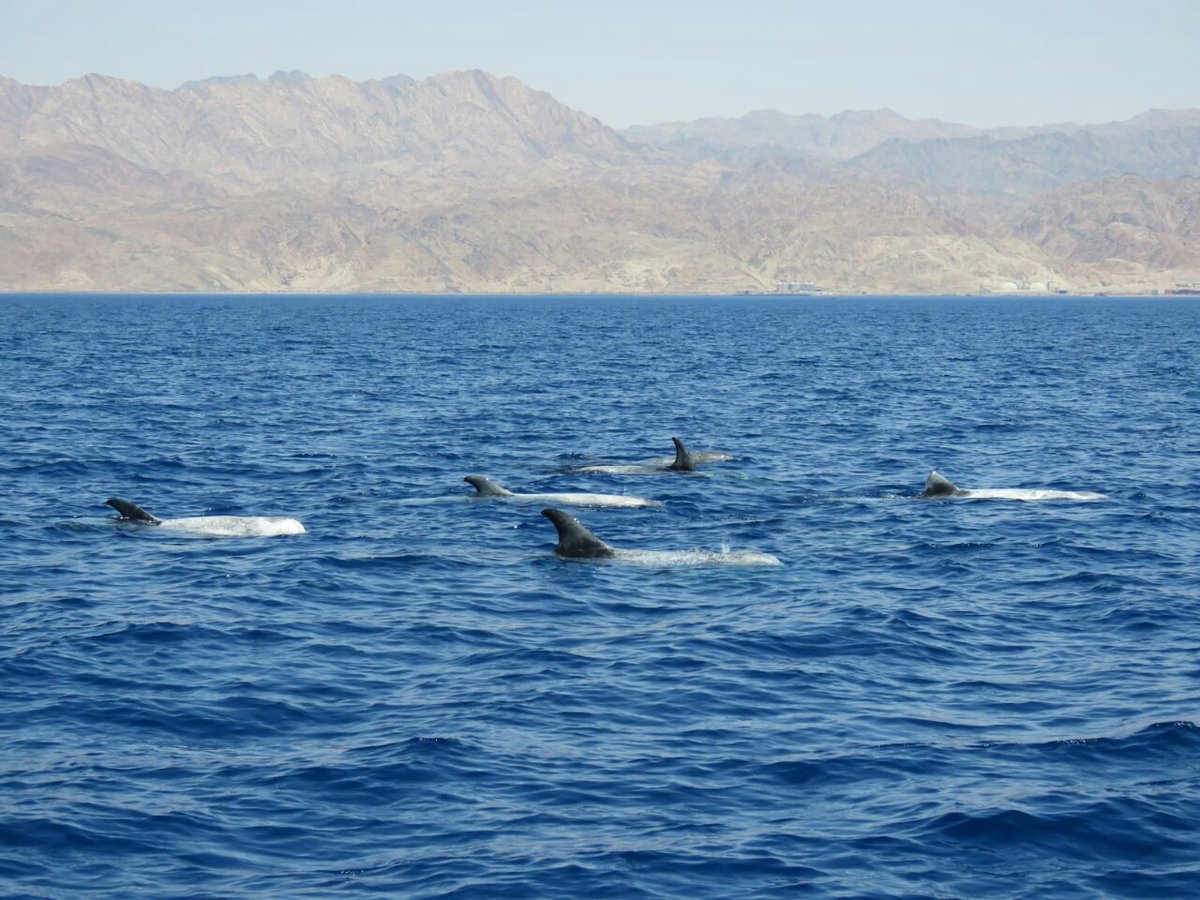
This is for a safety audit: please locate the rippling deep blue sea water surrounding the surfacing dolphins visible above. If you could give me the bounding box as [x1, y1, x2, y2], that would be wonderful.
[0, 295, 1200, 900]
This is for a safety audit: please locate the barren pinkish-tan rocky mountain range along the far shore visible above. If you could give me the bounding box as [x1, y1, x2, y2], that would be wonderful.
[0, 72, 1200, 293]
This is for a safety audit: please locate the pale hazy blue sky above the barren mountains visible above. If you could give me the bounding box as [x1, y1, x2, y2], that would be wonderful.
[0, 0, 1200, 127]
